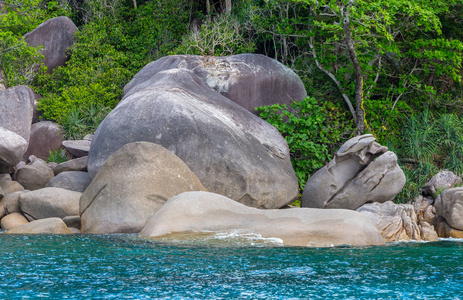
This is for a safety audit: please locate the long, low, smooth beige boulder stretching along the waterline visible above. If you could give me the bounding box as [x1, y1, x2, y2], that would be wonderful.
[140, 192, 384, 247]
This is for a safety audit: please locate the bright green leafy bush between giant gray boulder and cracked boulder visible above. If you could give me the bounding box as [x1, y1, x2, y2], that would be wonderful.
[257, 97, 353, 190]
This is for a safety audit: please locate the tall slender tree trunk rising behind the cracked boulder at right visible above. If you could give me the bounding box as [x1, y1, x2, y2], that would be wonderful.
[342, 0, 365, 135]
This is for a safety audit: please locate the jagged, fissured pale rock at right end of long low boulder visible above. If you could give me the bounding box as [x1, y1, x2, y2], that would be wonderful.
[357, 201, 437, 242]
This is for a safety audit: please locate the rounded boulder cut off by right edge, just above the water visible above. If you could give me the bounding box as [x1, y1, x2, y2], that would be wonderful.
[434, 187, 463, 230]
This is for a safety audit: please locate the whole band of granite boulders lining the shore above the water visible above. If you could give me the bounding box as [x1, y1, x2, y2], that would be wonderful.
[0, 18, 463, 247]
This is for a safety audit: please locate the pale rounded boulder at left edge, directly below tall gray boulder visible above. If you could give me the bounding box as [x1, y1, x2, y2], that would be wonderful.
[0, 126, 27, 172]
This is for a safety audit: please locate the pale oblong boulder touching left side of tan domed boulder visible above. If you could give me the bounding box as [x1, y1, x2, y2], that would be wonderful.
[19, 187, 82, 221]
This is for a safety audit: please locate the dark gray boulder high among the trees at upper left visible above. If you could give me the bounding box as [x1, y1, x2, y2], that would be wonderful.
[24, 16, 77, 73]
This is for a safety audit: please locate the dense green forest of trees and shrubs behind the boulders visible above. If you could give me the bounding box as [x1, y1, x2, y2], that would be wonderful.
[0, 0, 463, 202]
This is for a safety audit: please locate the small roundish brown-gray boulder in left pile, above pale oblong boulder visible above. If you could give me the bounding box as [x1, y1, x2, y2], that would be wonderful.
[15, 159, 54, 191]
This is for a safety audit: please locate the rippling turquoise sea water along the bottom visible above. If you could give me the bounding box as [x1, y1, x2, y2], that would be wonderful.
[0, 234, 463, 299]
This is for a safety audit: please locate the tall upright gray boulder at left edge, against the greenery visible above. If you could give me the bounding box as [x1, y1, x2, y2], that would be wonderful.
[0, 85, 35, 141]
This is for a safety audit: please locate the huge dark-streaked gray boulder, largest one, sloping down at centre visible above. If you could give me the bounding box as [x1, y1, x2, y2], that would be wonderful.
[88, 69, 298, 208]
